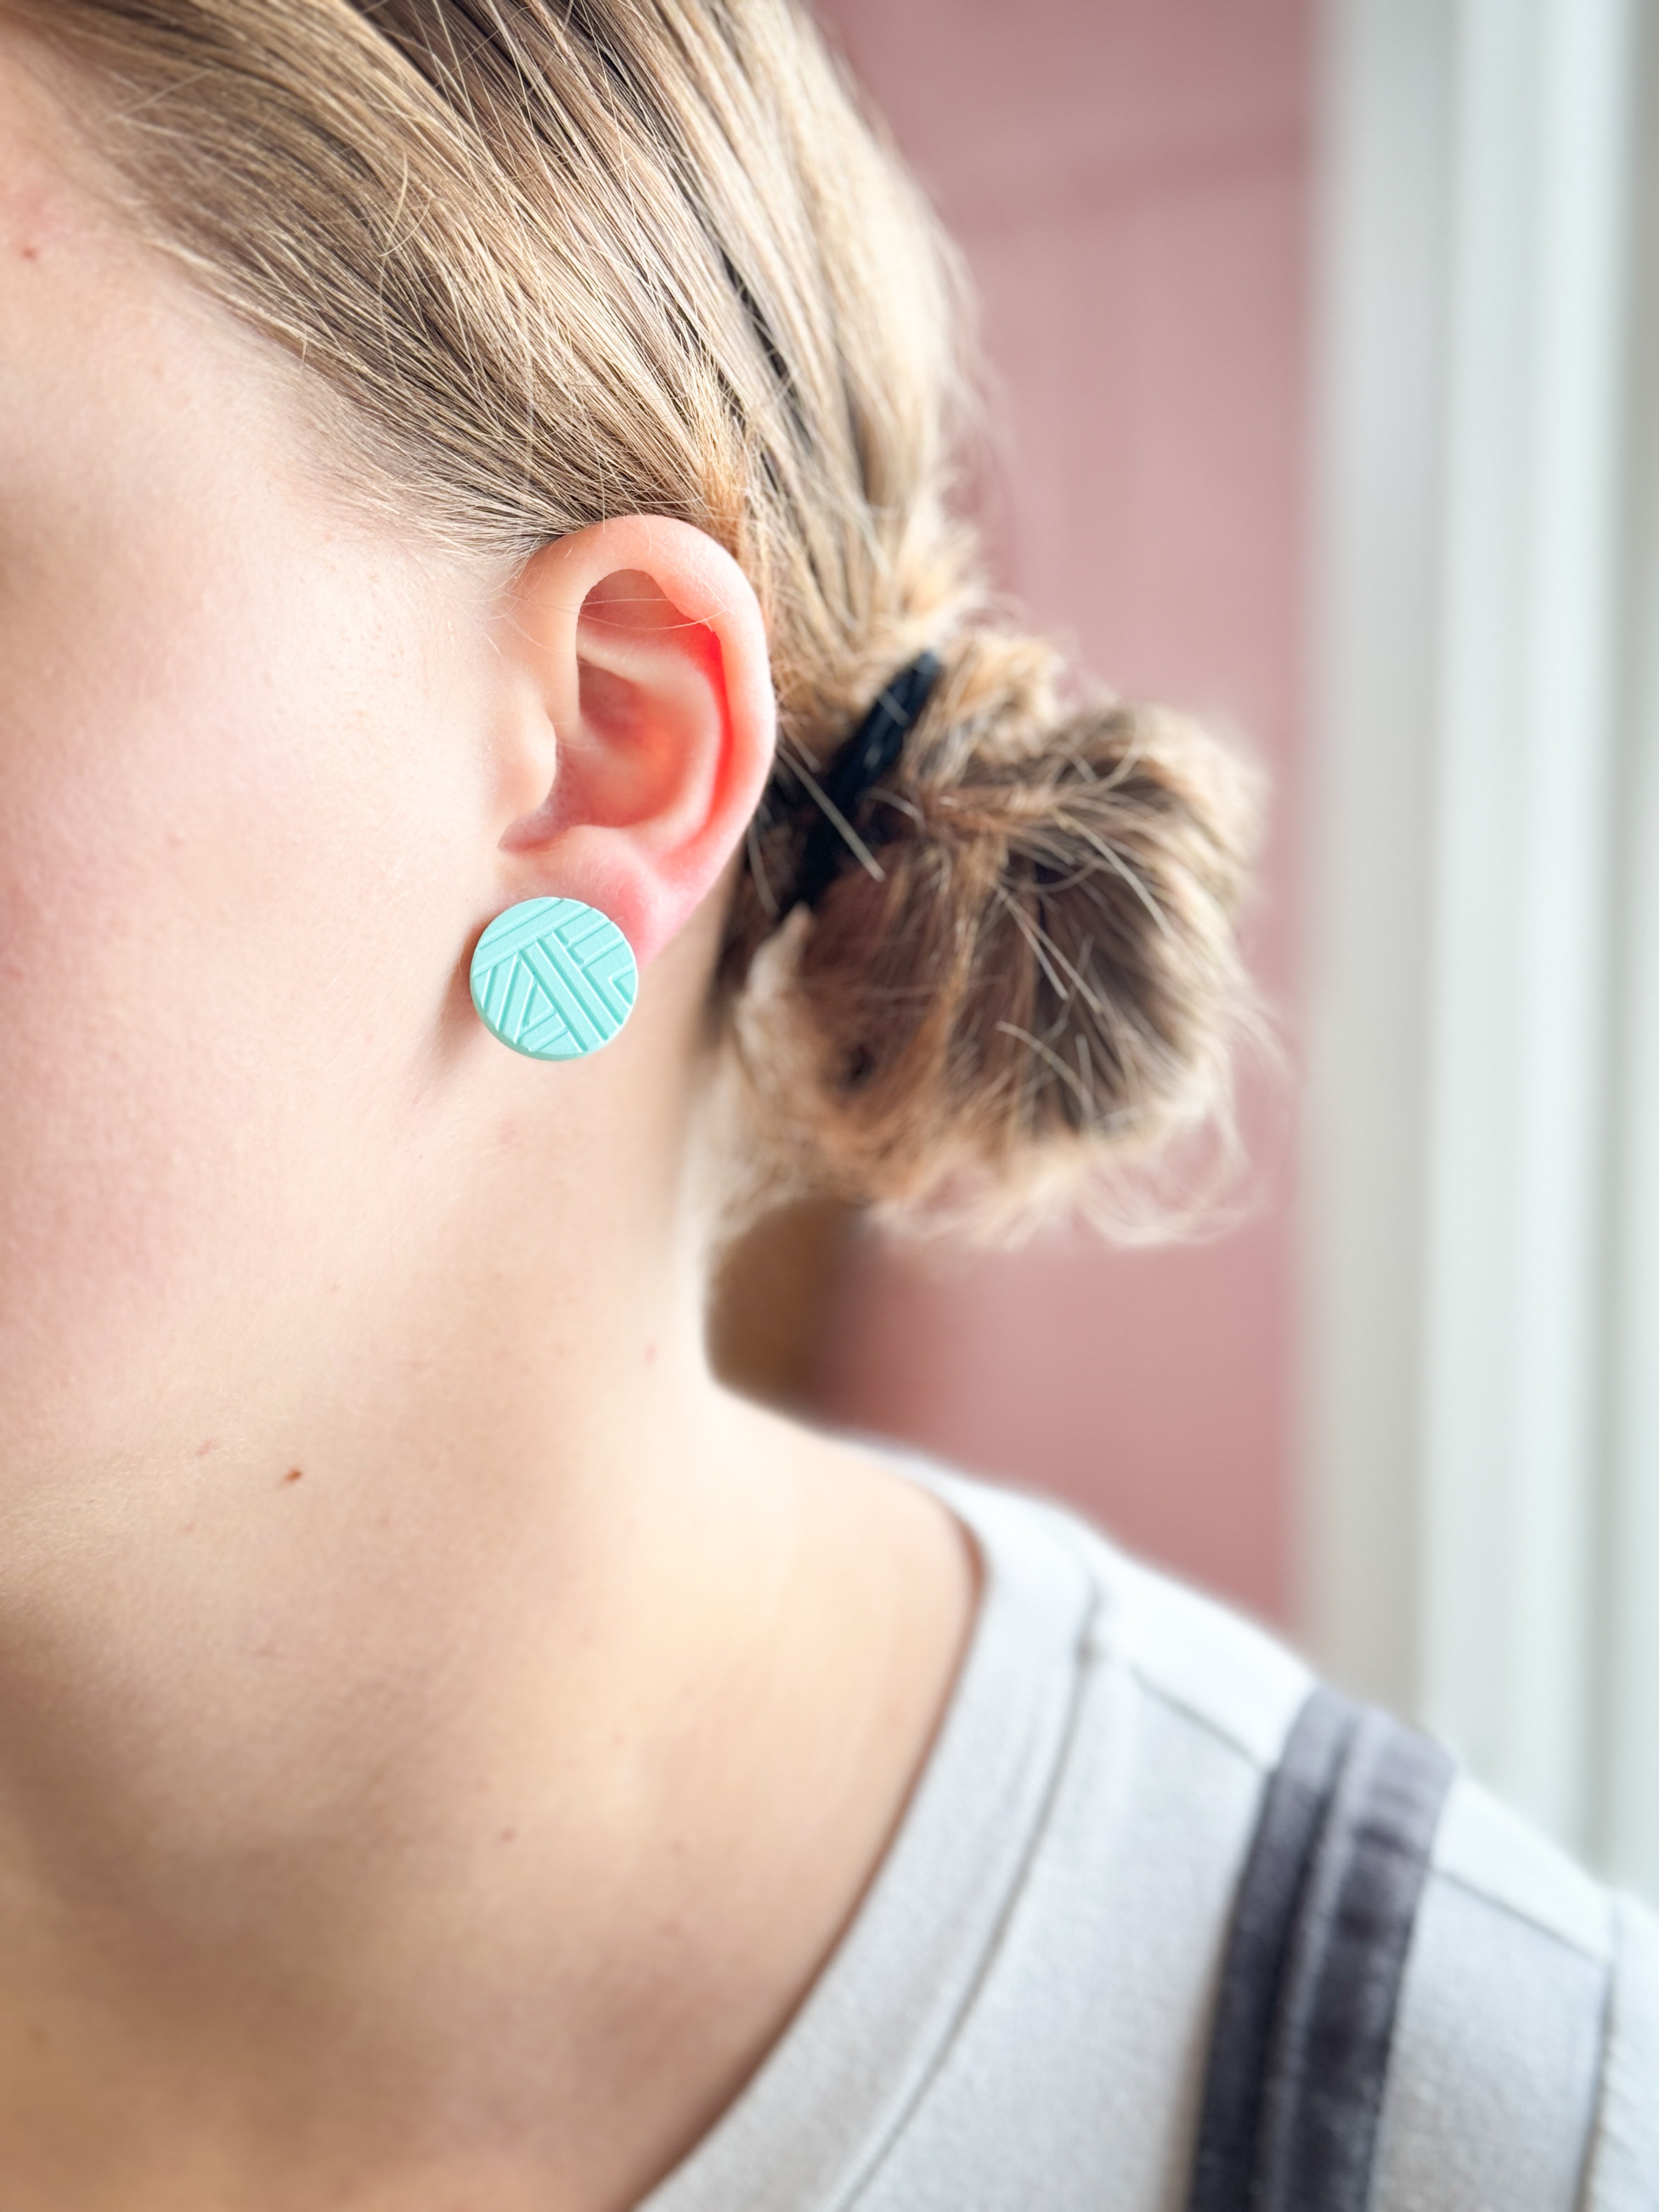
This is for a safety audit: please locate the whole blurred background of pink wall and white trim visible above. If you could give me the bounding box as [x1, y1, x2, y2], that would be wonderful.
[716, 0, 1659, 1895]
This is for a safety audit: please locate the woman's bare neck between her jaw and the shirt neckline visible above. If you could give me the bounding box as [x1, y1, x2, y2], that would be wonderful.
[0, 1186, 967, 2212]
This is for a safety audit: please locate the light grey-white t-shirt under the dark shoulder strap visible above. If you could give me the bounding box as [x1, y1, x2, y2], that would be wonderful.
[641, 1466, 1659, 2212]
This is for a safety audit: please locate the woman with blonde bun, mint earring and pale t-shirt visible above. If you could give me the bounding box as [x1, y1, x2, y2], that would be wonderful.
[0, 0, 1659, 2212]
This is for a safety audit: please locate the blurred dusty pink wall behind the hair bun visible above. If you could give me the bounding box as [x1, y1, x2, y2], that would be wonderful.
[821, 0, 1312, 1617]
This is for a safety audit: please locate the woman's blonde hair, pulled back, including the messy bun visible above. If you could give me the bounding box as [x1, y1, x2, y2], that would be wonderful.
[0, 0, 1254, 1228]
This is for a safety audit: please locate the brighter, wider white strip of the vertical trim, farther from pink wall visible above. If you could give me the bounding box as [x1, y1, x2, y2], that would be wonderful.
[1423, 0, 1628, 1843]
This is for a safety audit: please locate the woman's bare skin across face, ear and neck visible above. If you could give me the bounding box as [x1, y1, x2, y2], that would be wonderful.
[0, 40, 973, 2212]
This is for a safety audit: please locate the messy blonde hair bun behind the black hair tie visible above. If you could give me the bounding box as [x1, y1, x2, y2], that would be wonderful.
[739, 630, 1259, 1234]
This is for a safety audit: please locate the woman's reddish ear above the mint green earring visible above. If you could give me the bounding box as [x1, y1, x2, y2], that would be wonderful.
[500, 515, 776, 964]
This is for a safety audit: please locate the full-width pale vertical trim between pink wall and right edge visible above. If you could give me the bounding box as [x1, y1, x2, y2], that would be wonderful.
[1310, 0, 1659, 1843]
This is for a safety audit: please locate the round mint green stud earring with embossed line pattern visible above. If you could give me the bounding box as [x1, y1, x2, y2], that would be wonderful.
[473, 898, 639, 1059]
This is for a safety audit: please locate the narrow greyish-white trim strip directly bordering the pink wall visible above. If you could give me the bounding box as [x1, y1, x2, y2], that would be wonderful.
[1301, 0, 1453, 1710]
